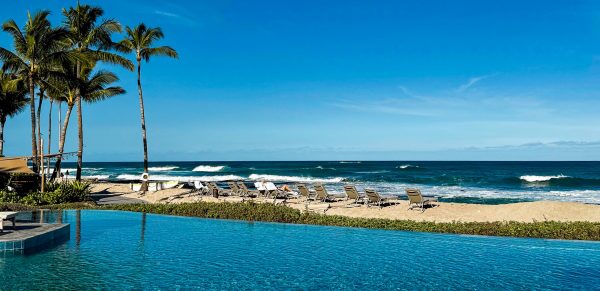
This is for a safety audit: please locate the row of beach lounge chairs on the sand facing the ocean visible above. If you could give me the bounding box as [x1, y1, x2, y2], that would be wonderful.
[194, 181, 438, 211]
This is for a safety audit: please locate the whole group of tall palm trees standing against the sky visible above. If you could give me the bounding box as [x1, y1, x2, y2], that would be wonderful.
[0, 2, 177, 192]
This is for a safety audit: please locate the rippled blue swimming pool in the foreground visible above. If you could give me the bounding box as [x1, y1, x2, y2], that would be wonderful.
[0, 210, 600, 290]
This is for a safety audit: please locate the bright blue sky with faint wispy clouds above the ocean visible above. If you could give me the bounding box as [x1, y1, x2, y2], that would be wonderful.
[0, 0, 600, 161]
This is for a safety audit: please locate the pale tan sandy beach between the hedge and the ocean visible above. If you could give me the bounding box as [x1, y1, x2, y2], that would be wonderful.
[92, 182, 600, 222]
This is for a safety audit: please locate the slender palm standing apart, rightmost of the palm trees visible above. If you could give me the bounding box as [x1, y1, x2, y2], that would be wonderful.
[118, 23, 178, 191]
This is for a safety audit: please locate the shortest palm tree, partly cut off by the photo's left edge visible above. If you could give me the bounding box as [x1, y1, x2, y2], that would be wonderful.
[0, 71, 27, 157]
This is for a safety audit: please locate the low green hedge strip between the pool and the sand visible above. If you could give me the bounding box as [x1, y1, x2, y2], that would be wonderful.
[0, 202, 600, 241]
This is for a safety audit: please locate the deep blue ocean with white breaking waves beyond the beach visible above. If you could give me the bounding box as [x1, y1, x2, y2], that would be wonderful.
[56, 161, 600, 204]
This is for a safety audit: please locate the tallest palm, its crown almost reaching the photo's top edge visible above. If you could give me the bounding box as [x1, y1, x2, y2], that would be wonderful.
[63, 2, 133, 180]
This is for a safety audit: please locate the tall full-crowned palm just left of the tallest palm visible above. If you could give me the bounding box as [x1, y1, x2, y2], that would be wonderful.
[0, 10, 68, 171]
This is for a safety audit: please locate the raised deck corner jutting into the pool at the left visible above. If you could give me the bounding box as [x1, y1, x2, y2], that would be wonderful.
[0, 221, 70, 254]
